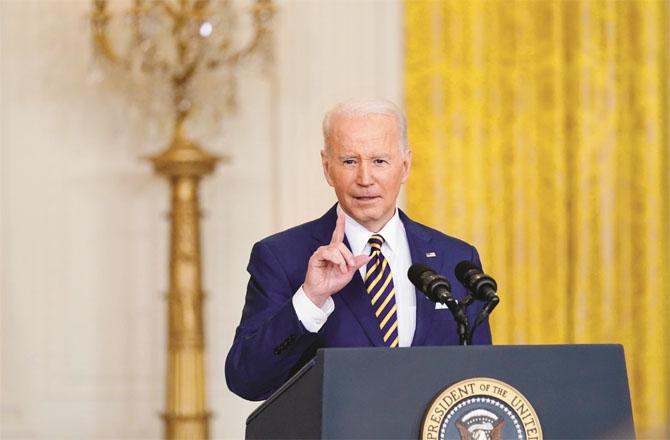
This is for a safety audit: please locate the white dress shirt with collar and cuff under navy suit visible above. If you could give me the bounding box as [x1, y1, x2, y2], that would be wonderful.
[293, 205, 416, 347]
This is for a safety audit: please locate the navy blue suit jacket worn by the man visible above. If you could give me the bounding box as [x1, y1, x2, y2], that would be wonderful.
[226, 207, 491, 400]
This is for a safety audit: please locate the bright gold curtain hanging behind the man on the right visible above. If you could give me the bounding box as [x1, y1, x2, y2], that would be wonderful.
[405, 0, 670, 438]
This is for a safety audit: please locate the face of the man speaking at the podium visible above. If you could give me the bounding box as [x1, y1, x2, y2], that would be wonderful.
[321, 114, 412, 232]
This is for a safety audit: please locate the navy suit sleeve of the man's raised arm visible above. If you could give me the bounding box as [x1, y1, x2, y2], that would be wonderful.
[226, 242, 317, 400]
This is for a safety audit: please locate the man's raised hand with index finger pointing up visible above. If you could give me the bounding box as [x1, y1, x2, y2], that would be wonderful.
[302, 212, 370, 307]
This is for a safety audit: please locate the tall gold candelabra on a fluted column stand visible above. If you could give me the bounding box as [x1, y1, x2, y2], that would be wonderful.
[90, 0, 275, 439]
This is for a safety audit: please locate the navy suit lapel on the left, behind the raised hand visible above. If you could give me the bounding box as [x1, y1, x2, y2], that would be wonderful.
[314, 205, 384, 347]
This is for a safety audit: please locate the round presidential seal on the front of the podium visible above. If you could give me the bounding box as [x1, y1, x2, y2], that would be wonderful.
[421, 377, 542, 440]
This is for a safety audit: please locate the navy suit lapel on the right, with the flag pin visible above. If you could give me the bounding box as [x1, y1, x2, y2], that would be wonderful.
[400, 211, 444, 346]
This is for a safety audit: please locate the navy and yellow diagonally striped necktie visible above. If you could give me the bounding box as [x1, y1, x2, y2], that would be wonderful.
[365, 234, 398, 347]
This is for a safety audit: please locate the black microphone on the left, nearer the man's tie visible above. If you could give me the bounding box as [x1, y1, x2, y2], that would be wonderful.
[407, 264, 470, 345]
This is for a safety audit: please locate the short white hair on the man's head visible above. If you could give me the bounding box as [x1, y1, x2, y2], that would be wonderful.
[323, 98, 409, 151]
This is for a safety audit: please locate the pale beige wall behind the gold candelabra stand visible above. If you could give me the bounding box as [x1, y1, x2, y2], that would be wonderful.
[0, 0, 402, 439]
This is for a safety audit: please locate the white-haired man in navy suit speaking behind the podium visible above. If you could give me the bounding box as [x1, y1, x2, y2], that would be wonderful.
[226, 100, 491, 400]
